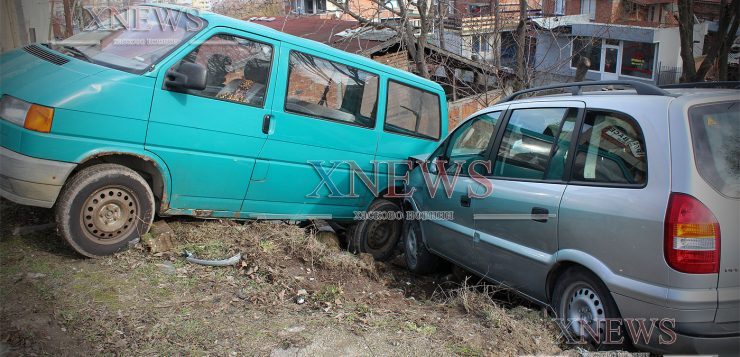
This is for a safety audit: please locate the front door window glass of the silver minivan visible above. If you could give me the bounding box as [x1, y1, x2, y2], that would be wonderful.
[445, 112, 501, 175]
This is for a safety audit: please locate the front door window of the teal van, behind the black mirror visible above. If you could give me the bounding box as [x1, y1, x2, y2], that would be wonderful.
[175, 34, 272, 107]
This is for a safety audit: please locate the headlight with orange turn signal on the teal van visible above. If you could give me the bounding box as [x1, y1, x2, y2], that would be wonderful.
[0, 95, 54, 133]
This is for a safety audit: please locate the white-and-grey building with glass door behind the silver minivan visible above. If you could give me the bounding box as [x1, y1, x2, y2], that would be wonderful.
[533, 0, 707, 84]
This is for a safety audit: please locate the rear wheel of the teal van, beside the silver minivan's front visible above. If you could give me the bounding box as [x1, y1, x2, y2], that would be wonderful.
[347, 198, 403, 261]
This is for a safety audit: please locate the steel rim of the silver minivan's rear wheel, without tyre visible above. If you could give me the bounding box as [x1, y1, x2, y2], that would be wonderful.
[561, 283, 606, 340]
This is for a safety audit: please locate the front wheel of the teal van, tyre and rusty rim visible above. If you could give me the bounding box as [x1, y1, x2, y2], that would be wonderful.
[56, 164, 155, 258]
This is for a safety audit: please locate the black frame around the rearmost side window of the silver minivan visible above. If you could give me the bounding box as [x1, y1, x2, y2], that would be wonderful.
[566, 107, 650, 189]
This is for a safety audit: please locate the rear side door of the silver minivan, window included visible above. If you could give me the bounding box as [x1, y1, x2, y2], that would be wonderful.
[473, 101, 585, 300]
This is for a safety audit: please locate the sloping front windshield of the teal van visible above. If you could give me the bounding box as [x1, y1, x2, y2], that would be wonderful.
[51, 6, 206, 73]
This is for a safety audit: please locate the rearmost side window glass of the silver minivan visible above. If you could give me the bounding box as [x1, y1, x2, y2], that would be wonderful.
[573, 111, 647, 185]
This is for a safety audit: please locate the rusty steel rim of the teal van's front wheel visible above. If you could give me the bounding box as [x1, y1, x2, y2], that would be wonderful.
[80, 186, 139, 244]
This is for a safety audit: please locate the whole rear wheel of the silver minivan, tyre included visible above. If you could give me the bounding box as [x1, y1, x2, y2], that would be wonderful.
[552, 267, 630, 350]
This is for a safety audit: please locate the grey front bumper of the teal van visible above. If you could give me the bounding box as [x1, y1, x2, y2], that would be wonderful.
[0, 147, 76, 208]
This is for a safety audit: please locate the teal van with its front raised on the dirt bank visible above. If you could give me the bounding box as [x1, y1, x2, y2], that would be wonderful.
[0, 5, 447, 259]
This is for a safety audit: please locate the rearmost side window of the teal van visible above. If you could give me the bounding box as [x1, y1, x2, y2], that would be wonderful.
[384, 81, 440, 140]
